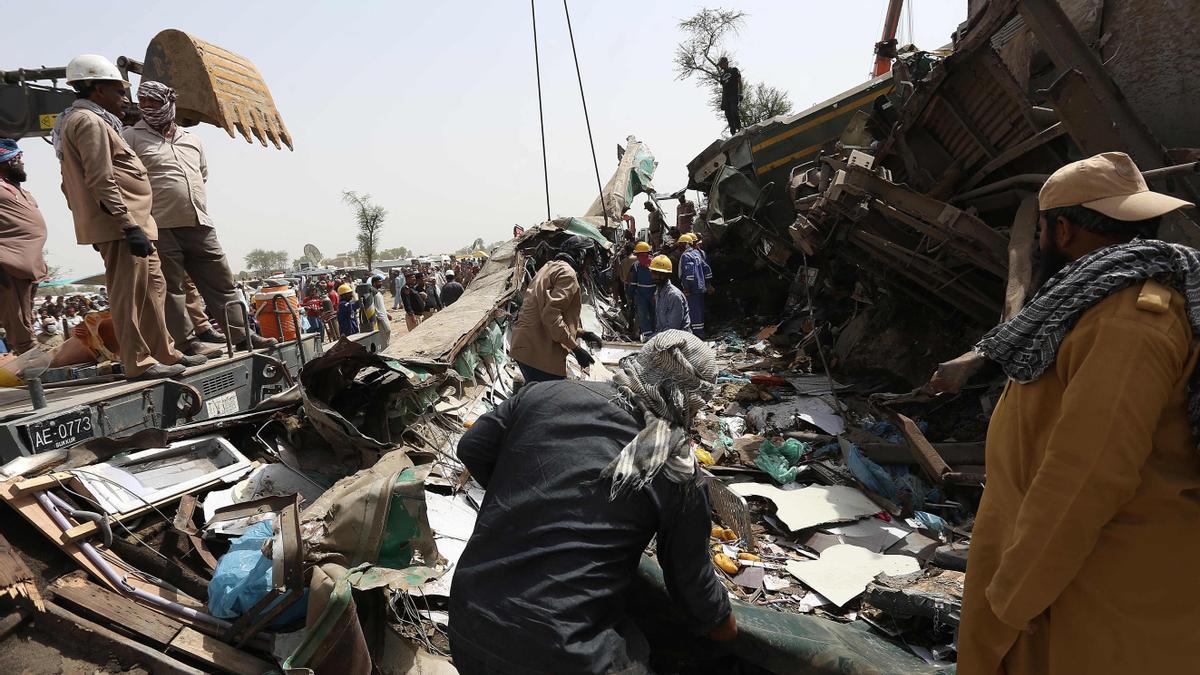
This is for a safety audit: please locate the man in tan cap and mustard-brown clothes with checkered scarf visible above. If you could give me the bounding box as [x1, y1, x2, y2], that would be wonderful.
[958, 153, 1200, 675]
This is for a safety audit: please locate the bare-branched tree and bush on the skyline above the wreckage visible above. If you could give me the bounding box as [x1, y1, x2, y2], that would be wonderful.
[674, 7, 792, 126]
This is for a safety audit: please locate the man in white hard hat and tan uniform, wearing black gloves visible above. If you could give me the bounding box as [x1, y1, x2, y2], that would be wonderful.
[52, 54, 206, 380]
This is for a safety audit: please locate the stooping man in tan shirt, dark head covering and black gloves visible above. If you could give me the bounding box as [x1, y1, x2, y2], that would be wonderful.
[511, 234, 600, 382]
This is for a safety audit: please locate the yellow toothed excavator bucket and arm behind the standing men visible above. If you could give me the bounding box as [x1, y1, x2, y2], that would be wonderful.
[0, 29, 292, 149]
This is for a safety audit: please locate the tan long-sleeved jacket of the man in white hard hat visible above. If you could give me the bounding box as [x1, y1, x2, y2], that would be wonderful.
[61, 109, 158, 244]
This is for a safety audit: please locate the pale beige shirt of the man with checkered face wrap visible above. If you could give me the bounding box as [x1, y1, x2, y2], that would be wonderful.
[121, 120, 212, 227]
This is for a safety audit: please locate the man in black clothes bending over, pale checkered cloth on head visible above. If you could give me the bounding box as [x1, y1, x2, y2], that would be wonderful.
[449, 330, 737, 675]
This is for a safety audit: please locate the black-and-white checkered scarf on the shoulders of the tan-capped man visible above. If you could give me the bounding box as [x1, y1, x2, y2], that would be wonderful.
[976, 239, 1200, 440]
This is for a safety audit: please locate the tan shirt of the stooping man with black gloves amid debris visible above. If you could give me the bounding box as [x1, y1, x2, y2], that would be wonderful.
[511, 261, 582, 375]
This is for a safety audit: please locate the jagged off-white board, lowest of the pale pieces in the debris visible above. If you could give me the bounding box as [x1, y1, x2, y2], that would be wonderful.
[787, 544, 920, 607]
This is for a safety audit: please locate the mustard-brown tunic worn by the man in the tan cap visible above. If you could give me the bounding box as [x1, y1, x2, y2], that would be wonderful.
[958, 281, 1200, 675]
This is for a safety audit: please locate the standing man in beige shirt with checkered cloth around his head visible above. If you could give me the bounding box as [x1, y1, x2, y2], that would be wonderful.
[121, 80, 275, 352]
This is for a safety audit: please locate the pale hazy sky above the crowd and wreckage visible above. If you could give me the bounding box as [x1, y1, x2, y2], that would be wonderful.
[7, 0, 966, 279]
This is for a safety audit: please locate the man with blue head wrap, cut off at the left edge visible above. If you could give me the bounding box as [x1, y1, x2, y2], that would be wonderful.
[0, 138, 48, 354]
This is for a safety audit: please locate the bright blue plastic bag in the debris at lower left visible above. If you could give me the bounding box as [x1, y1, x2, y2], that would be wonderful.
[209, 520, 308, 627]
